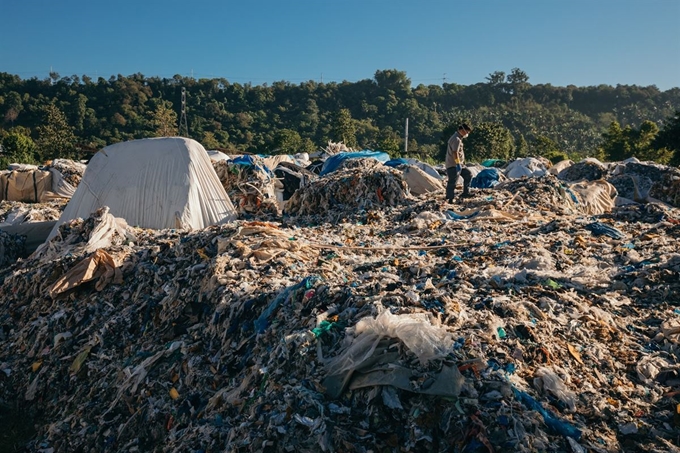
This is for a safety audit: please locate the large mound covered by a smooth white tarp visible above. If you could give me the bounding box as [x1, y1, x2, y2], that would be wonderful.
[50, 137, 237, 238]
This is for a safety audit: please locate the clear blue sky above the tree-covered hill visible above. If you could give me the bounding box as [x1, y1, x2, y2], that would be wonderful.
[0, 0, 680, 90]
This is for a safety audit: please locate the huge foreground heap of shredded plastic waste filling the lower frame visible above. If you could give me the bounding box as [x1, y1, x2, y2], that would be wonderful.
[0, 149, 680, 453]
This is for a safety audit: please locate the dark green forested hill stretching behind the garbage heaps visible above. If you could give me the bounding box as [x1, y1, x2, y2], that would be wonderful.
[0, 68, 680, 164]
